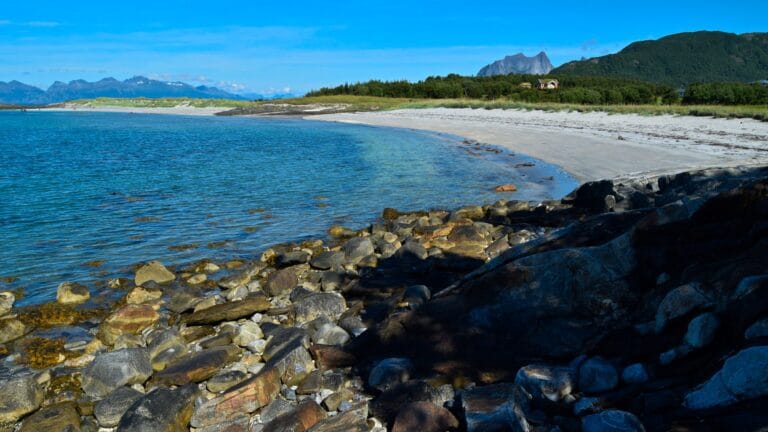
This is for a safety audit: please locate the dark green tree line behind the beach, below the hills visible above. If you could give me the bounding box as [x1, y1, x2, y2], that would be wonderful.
[307, 74, 768, 105]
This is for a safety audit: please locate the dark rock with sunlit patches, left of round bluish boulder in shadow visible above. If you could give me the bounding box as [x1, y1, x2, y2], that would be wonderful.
[515, 365, 576, 402]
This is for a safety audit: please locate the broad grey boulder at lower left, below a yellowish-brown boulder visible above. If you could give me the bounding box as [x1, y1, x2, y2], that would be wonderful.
[82, 348, 152, 398]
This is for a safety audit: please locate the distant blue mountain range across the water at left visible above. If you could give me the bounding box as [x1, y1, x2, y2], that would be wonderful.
[0, 76, 261, 105]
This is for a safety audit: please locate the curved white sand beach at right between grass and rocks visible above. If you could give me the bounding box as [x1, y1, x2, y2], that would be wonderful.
[309, 108, 768, 181]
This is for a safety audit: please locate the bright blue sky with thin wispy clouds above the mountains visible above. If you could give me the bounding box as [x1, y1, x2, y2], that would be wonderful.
[0, 0, 768, 93]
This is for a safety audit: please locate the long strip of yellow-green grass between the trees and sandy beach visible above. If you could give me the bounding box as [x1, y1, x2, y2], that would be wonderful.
[67, 95, 768, 121]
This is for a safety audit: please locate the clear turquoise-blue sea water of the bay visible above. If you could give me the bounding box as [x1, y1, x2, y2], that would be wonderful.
[0, 112, 576, 303]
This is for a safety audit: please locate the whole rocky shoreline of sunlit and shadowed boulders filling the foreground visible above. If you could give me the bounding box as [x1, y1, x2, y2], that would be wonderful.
[0, 167, 768, 432]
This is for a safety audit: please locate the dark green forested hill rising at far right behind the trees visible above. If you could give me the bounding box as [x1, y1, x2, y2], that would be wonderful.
[551, 31, 768, 86]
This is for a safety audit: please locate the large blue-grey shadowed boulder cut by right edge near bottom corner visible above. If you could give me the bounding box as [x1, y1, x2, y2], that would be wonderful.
[685, 346, 768, 410]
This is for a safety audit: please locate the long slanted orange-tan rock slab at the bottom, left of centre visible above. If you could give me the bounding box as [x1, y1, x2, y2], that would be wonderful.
[190, 368, 280, 428]
